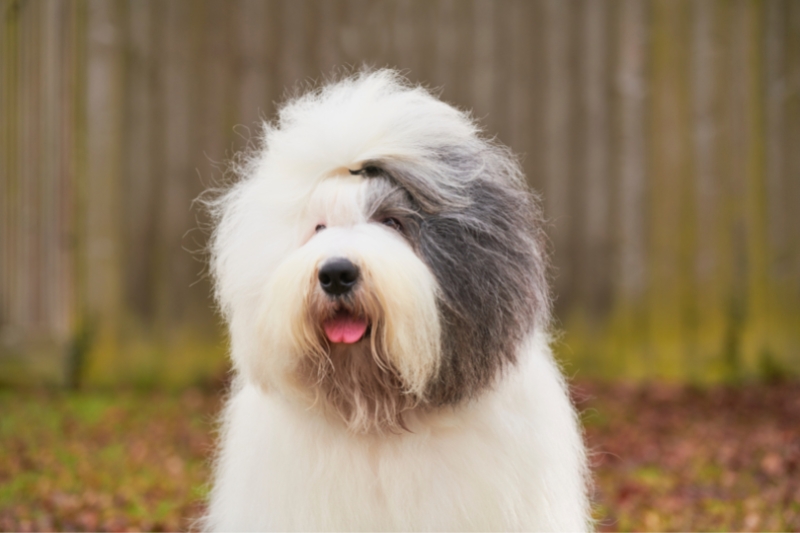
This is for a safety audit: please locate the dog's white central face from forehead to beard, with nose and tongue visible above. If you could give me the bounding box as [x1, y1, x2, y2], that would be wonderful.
[258, 171, 440, 429]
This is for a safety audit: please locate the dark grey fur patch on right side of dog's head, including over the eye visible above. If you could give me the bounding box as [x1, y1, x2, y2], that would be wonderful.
[362, 139, 550, 405]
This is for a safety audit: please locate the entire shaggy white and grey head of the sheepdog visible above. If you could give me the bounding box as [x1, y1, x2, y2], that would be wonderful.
[212, 71, 549, 431]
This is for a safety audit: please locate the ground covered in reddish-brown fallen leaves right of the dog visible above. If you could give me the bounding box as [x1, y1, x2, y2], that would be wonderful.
[573, 383, 800, 531]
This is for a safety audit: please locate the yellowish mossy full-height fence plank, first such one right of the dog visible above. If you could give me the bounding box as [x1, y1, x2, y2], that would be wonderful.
[648, 0, 694, 376]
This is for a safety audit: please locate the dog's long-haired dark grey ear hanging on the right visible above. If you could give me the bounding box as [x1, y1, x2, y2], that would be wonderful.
[419, 172, 549, 403]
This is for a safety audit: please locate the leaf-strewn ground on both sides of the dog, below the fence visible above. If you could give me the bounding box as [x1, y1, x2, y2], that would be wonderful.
[0, 381, 800, 531]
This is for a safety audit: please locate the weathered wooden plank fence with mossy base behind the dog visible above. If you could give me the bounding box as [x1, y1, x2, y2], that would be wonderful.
[0, 0, 800, 384]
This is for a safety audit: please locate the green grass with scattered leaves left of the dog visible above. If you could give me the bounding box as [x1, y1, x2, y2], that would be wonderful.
[0, 390, 219, 531]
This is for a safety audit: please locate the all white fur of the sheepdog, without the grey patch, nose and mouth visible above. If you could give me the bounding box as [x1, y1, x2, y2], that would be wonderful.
[205, 71, 590, 531]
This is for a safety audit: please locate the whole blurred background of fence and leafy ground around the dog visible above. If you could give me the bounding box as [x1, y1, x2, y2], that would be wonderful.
[0, 0, 800, 531]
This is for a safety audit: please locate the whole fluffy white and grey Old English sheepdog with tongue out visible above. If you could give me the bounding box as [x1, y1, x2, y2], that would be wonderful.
[204, 70, 591, 531]
